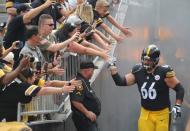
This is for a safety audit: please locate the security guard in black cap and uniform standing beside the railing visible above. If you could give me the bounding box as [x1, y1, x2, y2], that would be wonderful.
[70, 62, 101, 131]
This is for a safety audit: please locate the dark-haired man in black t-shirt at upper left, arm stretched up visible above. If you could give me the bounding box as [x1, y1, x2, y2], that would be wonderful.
[3, 0, 55, 67]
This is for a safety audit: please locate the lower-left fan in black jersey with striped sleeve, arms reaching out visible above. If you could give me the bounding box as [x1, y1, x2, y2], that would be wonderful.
[0, 68, 77, 122]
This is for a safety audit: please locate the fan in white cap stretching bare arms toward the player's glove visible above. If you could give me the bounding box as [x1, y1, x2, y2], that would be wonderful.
[55, 15, 109, 60]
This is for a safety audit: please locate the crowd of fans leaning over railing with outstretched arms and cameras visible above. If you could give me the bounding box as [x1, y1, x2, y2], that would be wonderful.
[0, 0, 132, 129]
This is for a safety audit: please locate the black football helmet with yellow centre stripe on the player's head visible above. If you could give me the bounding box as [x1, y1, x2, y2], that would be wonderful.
[141, 45, 160, 70]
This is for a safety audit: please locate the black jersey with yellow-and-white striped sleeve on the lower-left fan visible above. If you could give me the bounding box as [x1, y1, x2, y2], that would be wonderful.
[0, 80, 40, 121]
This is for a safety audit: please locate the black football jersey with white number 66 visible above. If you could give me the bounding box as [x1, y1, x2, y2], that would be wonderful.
[132, 64, 175, 111]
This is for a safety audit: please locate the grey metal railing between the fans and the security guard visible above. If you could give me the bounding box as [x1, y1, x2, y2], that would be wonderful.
[17, 53, 98, 125]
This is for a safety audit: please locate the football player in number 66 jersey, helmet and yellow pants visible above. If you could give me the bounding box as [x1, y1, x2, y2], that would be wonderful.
[109, 45, 184, 131]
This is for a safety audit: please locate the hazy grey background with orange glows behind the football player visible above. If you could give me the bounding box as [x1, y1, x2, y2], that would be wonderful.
[94, 0, 190, 131]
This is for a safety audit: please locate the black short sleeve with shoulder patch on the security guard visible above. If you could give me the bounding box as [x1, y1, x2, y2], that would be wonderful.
[70, 85, 85, 102]
